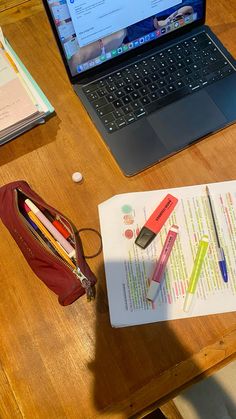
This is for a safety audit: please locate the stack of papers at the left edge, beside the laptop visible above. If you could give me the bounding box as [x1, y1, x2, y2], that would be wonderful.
[0, 28, 54, 144]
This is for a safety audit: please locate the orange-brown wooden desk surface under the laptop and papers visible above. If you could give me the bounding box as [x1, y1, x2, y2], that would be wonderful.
[0, 0, 236, 419]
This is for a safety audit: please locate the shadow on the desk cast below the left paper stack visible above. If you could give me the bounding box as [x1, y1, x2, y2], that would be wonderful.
[0, 114, 60, 166]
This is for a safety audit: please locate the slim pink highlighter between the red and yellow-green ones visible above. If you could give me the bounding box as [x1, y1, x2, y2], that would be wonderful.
[147, 225, 179, 301]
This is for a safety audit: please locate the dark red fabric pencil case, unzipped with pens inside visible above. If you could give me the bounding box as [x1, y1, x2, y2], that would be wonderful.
[0, 180, 99, 306]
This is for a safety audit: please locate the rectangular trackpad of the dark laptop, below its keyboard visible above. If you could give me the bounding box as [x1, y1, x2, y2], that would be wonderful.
[147, 90, 227, 152]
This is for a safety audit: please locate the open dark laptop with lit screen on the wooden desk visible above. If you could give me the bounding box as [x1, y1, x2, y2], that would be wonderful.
[43, 0, 236, 176]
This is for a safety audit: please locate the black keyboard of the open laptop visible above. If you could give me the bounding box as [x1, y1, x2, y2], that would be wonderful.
[83, 32, 235, 133]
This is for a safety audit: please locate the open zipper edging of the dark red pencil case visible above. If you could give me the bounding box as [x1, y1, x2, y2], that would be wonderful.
[14, 188, 95, 301]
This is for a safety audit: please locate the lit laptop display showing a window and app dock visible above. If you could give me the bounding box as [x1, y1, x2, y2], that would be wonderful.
[45, 0, 205, 77]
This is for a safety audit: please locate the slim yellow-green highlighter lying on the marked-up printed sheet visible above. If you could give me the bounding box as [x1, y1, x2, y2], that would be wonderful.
[183, 236, 209, 312]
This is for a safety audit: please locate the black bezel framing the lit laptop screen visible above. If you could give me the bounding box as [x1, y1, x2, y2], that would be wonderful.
[43, 0, 206, 84]
